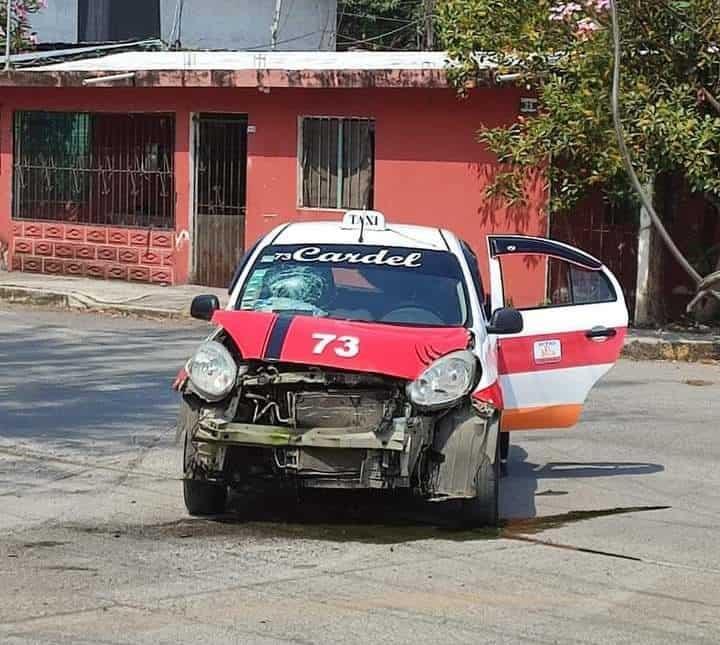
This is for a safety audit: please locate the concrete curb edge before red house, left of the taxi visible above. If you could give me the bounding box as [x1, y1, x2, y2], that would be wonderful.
[0, 285, 189, 320]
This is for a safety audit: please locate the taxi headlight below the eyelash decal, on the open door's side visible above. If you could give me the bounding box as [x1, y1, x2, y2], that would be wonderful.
[407, 351, 477, 408]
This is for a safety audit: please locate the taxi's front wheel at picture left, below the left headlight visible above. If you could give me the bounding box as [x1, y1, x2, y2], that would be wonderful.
[178, 399, 227, 515]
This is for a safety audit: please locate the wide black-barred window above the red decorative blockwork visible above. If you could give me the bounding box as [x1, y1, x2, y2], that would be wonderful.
[13, 112, 175, 229]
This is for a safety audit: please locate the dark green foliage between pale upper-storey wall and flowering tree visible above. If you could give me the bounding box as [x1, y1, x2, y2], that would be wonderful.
[337, 0, 435, 50]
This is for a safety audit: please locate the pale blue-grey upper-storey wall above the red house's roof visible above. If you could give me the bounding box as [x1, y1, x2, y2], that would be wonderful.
[31, 0, 337, 51]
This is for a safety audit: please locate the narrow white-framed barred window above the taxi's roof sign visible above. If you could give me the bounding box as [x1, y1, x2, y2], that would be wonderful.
[300, 117, 375, 209]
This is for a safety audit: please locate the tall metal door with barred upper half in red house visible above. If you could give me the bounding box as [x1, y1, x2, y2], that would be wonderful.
[194, 114, 247, 287]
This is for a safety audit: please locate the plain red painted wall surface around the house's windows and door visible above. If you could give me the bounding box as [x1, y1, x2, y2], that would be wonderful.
[0, 88, 547, 290]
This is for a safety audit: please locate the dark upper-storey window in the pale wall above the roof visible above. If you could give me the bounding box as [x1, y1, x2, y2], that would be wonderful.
[78, 0, 160, 43]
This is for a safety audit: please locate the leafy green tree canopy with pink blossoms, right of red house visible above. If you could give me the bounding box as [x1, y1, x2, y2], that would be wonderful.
[438, 0, 720, 317]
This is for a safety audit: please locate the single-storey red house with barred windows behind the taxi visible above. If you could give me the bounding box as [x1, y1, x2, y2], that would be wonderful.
[0, 52, 548, 298]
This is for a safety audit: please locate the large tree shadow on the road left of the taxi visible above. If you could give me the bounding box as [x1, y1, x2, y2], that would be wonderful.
[0, 321, 201, 450]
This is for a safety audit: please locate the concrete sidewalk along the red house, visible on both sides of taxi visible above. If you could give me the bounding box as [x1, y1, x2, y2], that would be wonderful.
[0, 271, 720, 361]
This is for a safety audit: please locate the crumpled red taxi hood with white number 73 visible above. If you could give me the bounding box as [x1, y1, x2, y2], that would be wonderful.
[213, 311, 470, 380]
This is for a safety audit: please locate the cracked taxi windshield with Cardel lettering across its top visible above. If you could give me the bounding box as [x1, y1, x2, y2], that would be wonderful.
[238, 245, 468, 327]
